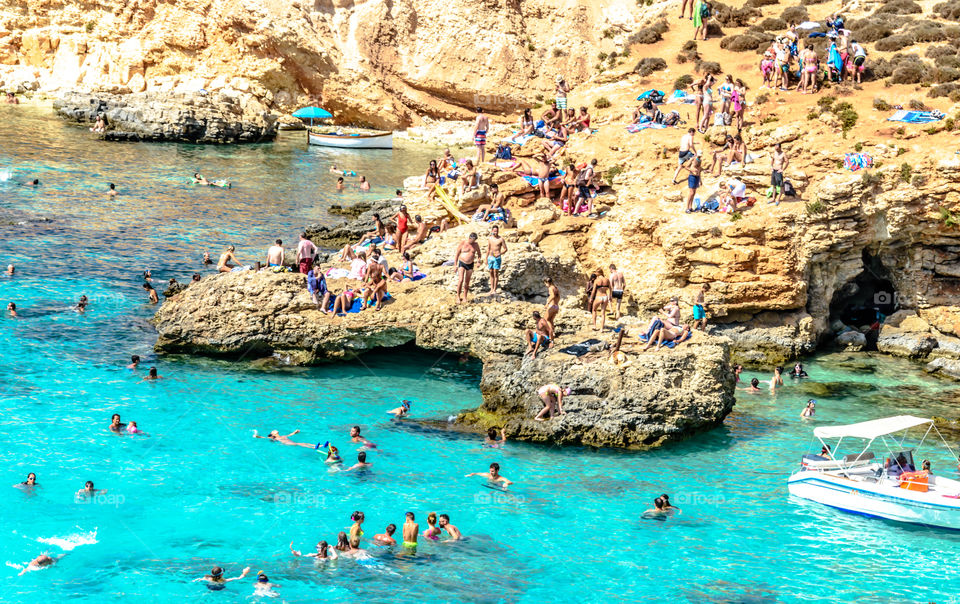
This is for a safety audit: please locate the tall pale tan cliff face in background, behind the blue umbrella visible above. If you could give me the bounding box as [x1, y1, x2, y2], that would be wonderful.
[0, 0, 656, 128]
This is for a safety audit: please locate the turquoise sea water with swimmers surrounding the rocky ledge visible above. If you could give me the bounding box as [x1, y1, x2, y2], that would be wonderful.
[0, 106, 960, 602]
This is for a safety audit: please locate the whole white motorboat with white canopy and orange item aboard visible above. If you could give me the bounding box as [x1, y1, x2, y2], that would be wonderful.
[787, 415, 960, 529]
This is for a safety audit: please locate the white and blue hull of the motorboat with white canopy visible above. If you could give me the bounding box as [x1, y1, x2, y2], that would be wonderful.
[787, 472, 960, 530]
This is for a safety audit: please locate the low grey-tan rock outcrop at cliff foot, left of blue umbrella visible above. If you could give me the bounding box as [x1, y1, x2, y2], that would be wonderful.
[53, 92, 277, 143]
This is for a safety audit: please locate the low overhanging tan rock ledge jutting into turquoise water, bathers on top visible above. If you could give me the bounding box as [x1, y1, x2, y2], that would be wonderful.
[155, 271, 734, 448]
